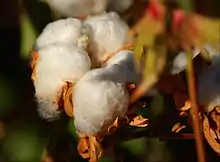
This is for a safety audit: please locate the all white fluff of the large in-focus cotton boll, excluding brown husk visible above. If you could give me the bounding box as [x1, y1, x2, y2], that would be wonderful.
[33, 12, 131, 125]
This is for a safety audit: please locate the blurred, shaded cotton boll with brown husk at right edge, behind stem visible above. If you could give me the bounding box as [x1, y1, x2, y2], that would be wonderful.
[173, 44, 220, 153]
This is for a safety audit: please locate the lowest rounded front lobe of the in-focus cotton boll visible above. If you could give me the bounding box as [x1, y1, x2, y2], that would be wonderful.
[72, 67, 129, 136]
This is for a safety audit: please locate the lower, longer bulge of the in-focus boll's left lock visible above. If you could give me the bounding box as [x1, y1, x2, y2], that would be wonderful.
[34, 43, 91, 120]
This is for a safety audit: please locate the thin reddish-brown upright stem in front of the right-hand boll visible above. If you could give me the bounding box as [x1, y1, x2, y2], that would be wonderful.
[187, 51, 206, 162]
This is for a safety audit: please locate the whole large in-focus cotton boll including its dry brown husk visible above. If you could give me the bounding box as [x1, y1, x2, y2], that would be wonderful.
[31, 9, 148, 161]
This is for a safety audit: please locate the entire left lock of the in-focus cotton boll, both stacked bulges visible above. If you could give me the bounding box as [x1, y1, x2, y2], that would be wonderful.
[34, 18, 91, 121]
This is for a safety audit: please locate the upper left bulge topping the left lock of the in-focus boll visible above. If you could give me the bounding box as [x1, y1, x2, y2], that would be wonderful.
[35, 18, 88, 49]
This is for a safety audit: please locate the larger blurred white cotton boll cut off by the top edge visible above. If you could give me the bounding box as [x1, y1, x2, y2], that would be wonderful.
[40, 0, 109, 17]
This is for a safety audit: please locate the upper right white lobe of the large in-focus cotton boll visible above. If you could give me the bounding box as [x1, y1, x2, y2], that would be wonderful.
[85, 12, 129, 67]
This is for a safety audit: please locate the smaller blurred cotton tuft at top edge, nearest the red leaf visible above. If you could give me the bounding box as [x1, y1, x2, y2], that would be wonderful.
[108, 0, 134, 13]
